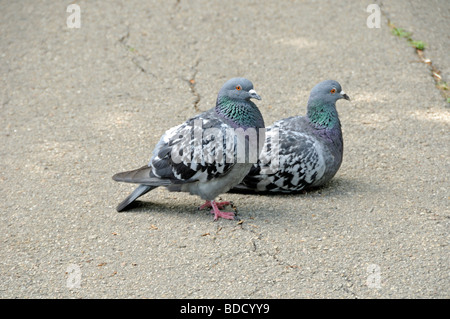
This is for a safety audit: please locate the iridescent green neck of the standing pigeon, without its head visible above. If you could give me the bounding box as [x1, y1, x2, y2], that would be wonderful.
[216, 96, 264, 128]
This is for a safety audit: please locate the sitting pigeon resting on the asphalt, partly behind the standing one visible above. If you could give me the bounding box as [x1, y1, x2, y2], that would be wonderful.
[233, 80, 350, 193]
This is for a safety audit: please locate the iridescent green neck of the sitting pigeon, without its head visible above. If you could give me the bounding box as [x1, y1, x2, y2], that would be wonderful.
[307, 100, 341, 129]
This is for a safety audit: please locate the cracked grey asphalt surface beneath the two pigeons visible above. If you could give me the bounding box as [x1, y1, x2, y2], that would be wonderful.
[0, 0, 450, 298]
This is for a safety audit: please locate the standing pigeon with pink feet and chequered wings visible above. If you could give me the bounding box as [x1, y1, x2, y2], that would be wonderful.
[113, 78, 265, 220]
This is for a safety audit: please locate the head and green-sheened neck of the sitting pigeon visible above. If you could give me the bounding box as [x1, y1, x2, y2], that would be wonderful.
[307, 80, 350, 129]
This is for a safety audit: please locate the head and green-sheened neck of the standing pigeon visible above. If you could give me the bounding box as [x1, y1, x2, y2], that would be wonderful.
[216, 78, 264, 128]
